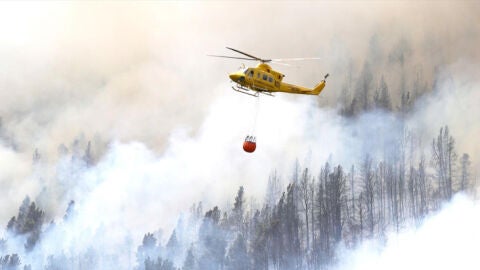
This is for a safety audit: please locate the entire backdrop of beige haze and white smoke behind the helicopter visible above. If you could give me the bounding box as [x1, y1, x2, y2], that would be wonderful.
[0, 2, 480, 265]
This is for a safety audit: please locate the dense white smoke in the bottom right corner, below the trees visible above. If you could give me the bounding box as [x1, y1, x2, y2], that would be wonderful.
[337, 195, 480, 269]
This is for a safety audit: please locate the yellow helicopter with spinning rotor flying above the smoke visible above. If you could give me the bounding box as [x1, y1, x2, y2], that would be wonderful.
[208, 47, 328, 97]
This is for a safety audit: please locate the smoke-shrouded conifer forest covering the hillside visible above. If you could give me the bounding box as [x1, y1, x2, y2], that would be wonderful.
[0, 58, 476, 270]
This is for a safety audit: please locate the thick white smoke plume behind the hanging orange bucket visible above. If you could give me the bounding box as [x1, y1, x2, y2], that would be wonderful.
[2, 62, 478, 269]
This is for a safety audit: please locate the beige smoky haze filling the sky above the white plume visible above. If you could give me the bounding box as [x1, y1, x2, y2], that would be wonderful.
[0, 1, 480, 158]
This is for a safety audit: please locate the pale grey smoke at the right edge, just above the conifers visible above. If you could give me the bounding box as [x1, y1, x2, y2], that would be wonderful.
[409, 59, 480, 162]
